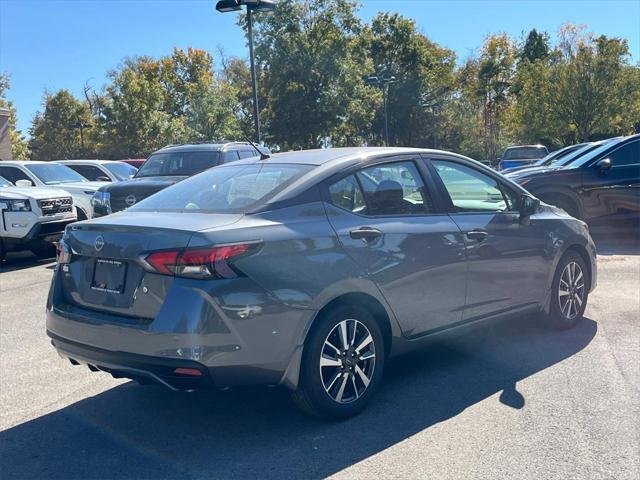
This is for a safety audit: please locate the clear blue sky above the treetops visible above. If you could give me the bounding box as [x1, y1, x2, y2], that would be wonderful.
[0, 0, 640, 135]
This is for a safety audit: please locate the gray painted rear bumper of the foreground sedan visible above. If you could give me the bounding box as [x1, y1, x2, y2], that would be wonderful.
[46, 269, 315, 389]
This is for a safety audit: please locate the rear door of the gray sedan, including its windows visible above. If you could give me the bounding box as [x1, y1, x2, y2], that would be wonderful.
[325, 157, 466, 337]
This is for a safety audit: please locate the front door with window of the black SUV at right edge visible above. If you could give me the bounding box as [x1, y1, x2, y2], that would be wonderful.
[579, 140, 640, 221]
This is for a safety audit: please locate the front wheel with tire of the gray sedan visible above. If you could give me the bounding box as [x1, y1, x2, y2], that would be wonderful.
[547, 251, 591, 330]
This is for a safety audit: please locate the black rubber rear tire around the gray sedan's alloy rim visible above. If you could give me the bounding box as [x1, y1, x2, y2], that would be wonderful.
[299, 305, 386, 418]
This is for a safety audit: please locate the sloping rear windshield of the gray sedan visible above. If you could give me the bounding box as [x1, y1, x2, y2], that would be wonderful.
[129, 162, 313, 213]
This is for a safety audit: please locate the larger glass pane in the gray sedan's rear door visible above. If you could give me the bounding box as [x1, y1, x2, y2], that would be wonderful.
[356, 161, 433, 215]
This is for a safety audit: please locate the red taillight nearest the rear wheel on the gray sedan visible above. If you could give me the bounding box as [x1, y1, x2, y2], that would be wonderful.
[144, 243, 259, 279]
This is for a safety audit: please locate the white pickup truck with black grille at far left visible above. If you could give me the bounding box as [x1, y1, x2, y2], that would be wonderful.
[0, 177, 76, 262]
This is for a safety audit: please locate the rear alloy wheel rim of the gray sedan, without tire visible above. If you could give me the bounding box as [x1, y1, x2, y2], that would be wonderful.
[320, 319, 376, 403]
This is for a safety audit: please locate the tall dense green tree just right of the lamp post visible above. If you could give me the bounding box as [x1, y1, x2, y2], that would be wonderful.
[251, 0, 380, 149]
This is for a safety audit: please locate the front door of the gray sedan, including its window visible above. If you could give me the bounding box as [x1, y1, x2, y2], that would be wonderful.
[427, 157, 552, 321]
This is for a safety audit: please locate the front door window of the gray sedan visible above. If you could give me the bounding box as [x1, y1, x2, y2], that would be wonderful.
[431, 160, 517, 212]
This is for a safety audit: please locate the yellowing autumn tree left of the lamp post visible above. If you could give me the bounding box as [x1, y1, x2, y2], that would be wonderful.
[101, 48, 240, 158]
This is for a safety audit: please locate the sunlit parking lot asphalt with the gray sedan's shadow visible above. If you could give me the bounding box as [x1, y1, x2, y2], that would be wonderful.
[0, 231, 640, 479]
